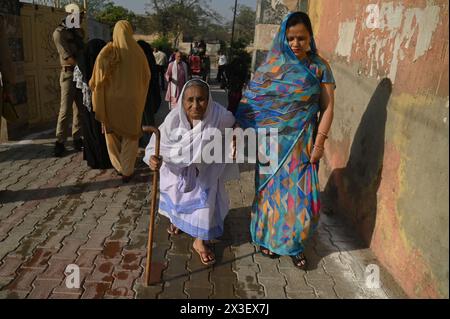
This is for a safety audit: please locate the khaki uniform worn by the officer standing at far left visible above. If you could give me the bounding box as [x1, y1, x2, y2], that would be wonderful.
[53, 26, 83, 143]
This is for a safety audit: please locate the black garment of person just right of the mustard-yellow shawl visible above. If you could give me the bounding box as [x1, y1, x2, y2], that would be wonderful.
[138, 40, 161, 147]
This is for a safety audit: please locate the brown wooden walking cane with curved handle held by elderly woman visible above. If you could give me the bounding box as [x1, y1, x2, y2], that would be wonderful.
[143, 126, 161, 286]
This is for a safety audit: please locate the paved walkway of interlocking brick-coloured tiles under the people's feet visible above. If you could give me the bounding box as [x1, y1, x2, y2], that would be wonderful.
[0, 85, 404, 299]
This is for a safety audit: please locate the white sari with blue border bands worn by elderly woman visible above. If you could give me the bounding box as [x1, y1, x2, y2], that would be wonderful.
[144, 80, 239, 240]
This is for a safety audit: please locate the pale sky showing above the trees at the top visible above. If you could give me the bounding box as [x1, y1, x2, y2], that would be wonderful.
[114, 0, 256, 21]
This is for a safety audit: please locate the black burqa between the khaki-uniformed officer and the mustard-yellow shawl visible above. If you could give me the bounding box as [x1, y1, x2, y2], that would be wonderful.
[78, 39, 112, 169]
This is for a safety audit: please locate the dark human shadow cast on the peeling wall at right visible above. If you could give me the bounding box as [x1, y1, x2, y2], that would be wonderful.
[324, 78, 392, 247]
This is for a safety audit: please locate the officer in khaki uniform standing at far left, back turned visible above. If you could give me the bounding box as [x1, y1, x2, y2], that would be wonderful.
[53, 4, 84, 157]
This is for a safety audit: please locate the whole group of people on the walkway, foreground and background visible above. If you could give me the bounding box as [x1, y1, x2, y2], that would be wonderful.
[49, 4, 335, 269]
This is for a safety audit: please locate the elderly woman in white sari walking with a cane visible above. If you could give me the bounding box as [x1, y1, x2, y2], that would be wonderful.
[144, 79, 238, 265]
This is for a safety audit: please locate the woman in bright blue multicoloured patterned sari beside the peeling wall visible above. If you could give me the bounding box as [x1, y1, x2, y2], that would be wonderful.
[236, 12, 335, 269]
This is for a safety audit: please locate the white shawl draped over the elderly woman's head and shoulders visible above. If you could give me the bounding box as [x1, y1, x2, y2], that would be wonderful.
[144, 79, 237, 191]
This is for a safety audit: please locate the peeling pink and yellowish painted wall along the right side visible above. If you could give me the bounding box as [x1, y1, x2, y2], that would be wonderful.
[309, 0, 449, 298]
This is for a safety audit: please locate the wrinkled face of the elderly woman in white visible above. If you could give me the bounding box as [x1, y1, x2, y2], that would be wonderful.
[183, 86, 209, 124]
